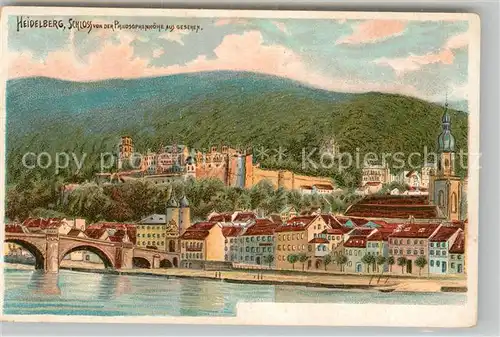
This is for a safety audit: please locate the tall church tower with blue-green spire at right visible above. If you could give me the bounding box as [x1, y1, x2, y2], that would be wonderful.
[429, 103, 462, 220]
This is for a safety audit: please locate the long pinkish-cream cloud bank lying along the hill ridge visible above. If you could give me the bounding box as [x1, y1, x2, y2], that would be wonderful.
[8, 30, 430, 98]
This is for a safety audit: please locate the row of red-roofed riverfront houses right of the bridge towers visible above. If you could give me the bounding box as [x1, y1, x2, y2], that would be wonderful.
[176, 210, 465, 275]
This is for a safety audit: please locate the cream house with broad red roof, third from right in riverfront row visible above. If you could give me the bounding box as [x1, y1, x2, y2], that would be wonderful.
[389, 223, 441, 274]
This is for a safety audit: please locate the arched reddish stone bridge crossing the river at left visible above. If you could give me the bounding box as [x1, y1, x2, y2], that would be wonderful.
[5, 229, 179, 273]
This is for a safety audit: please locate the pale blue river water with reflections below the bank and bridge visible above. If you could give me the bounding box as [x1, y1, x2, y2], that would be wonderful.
[4, 269, 466, 316]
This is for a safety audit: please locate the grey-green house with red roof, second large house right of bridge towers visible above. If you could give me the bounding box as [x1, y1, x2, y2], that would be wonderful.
[236, 219, 280, 266]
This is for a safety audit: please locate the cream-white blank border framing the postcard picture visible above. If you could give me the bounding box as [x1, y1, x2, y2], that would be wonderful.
[0, 7, 480, 327]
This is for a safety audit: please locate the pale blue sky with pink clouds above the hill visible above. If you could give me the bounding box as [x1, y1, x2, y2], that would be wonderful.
[8, 16, 470, 102]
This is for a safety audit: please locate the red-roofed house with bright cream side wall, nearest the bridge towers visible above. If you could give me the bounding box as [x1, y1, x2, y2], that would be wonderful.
[180, 222, 226, 268]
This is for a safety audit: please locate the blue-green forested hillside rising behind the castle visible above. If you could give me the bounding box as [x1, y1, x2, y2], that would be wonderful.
[7, 72, 467, 182]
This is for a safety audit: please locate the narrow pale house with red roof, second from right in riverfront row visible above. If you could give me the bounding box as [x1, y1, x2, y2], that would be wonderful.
[428, 226, 462, 274]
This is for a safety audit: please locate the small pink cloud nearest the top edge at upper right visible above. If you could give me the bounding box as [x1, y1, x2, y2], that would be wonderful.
[336, 20, 406, 45]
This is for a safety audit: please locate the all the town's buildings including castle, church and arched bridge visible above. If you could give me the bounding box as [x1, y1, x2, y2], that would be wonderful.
[4, 105, 468, 276]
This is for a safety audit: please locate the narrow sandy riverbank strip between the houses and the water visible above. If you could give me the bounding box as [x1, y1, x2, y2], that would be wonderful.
[5, 261, 467, 293]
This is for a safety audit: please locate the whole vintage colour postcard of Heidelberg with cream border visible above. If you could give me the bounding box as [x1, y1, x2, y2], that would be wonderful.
[0, 7, 480, 327]
